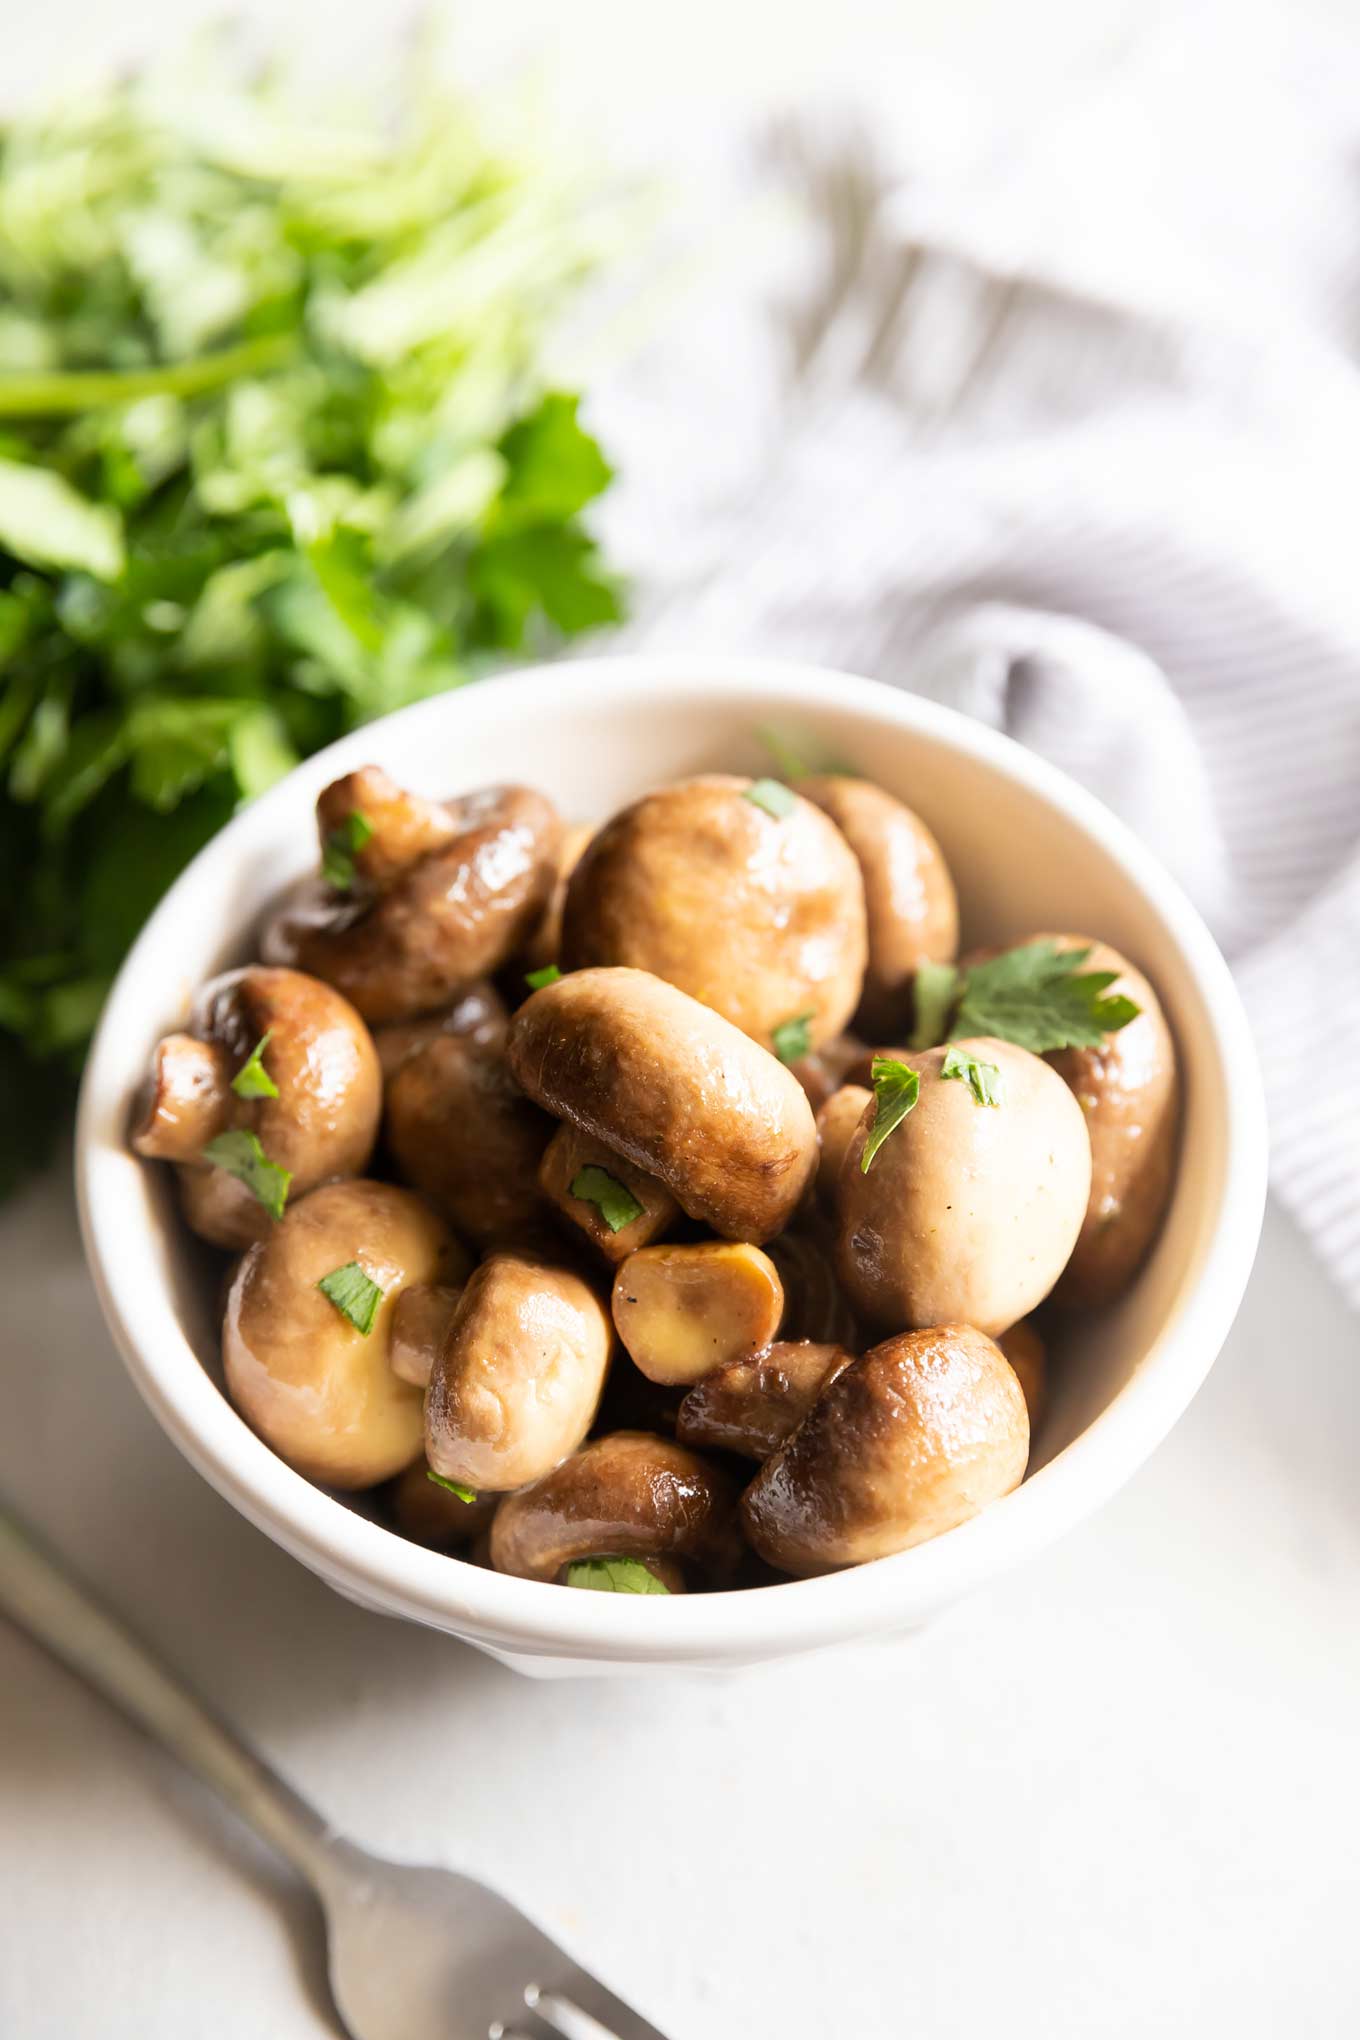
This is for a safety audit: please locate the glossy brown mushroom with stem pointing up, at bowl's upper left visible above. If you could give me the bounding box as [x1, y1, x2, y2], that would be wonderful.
[263, 765, 561, 1024]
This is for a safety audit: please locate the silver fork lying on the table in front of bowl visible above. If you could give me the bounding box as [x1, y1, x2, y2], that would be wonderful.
[0, 1510, 665, 2040]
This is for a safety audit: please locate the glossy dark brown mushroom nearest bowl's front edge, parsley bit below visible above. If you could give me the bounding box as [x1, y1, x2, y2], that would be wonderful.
[491, 1430, 740, 1579]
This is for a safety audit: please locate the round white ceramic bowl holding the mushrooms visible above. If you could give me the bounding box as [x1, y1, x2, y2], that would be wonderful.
[77, 659, 1266, 1677]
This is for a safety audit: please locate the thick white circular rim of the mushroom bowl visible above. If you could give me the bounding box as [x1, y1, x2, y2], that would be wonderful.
[75, 653, 1266, 1667]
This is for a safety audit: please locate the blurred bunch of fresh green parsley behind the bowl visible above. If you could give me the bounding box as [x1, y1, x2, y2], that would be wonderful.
[0, 63, 618, 1187]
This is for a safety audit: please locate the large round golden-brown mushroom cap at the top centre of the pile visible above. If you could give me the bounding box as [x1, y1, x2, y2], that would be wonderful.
[563, 773, 867, 1049]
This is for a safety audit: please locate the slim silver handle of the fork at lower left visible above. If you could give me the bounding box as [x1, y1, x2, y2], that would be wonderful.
[0, 1508, 336, 1889]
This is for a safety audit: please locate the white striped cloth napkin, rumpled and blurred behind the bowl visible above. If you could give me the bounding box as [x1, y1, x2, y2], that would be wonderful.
[601, 4, 1360, 1306]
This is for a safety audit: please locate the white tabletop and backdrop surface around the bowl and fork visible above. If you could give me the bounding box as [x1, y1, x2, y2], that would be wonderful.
[0, 0, 1360, 2040]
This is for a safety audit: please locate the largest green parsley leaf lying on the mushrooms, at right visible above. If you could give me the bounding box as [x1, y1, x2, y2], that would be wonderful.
[950, 942, 1138, 1055]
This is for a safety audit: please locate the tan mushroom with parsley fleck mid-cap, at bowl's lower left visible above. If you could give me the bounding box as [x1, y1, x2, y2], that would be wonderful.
[222, 1177, 459, 1487]
